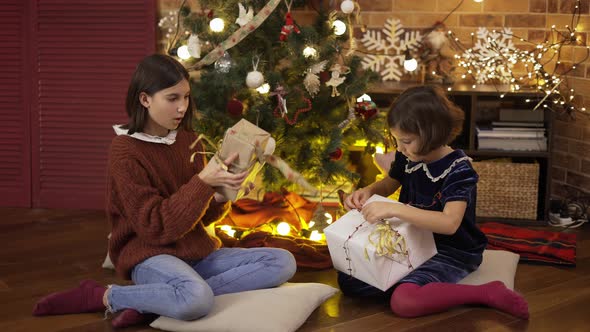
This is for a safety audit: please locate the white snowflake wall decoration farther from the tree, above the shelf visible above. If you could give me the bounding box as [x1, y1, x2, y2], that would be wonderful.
[459, 27, 519, 84]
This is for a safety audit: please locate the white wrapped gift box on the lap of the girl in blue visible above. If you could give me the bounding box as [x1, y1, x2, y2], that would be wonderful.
[324, 195, 437, 291]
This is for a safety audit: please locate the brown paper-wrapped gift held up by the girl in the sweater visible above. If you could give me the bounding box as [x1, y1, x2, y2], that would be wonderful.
[212, 119, 275, 201]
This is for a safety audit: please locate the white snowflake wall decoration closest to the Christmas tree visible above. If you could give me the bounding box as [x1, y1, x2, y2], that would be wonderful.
[361, 18, 422, 81]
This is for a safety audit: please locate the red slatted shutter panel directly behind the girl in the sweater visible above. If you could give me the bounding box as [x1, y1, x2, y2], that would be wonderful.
[32, 0, 156, 209]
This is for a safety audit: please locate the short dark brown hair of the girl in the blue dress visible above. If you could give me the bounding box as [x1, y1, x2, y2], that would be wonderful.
[387, 86, 465, 155]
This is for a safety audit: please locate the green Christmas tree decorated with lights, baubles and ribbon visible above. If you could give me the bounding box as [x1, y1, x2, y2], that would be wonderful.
[160, 0, 385, 196]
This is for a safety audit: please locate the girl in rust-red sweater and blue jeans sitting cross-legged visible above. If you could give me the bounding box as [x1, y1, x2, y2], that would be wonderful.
[33, 54, 296, 327]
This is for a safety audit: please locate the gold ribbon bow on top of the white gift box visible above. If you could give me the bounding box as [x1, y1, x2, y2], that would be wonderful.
[365, 220, 409, 261]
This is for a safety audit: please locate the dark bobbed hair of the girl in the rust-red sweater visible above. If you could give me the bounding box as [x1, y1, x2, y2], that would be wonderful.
[125, 54, 195, 135]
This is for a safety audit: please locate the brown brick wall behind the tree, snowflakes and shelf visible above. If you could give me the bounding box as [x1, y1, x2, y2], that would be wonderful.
[159, 0, 590, 197]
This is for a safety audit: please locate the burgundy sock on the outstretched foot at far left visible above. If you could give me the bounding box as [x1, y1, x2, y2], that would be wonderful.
[33, 280, 106, 316]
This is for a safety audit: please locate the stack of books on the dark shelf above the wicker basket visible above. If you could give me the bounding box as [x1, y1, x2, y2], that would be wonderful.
[476, 109, 547, 151]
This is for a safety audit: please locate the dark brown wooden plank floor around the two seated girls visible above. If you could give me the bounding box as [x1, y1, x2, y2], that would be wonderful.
[0, 208, 590, 332]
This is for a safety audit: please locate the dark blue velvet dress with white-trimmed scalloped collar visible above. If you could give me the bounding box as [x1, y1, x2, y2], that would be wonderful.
[338, 150, 487, 297]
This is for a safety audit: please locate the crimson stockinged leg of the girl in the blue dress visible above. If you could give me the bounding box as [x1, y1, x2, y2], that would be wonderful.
[390, 281, 529, 319]
